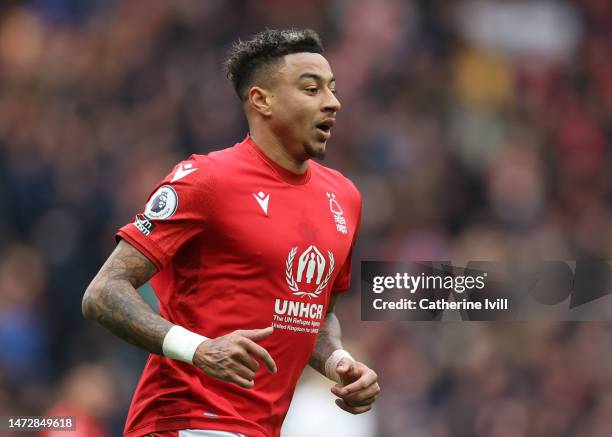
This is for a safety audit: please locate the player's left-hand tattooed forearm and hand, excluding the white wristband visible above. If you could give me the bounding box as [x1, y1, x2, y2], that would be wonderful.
[83, 240, 276, 388]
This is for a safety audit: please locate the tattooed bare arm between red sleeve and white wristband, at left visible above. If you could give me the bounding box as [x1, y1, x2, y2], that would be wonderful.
[83, 240, 172, 354]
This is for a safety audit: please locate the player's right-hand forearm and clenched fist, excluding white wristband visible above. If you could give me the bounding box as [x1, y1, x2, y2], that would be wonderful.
[309, 295, 380, 414]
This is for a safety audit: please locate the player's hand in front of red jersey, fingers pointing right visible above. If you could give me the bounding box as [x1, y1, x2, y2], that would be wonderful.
[193, 326, 276, 388]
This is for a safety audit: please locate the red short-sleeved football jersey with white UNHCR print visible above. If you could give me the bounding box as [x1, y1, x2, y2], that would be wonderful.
[117, 136, 361, 437]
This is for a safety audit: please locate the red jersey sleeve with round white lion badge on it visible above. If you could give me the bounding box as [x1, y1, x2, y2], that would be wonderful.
[117, 155, 214, 270]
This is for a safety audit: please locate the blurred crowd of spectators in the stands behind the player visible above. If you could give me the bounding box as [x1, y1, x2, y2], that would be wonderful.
[0, 0, 612, 437]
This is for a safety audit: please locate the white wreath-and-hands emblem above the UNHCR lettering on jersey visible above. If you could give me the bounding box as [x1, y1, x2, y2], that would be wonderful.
[285, 245, 334, 298]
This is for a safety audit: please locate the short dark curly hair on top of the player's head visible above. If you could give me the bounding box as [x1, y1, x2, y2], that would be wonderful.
[223, 29, 323, 101]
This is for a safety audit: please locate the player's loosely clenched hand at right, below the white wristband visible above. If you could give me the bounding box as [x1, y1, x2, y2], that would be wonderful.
[331, 358, 380, 414]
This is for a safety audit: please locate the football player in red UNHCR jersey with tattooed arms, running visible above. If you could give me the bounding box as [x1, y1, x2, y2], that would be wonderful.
[83, 30, 380, 437]
